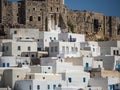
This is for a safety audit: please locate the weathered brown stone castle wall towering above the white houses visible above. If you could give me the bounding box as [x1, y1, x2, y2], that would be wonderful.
[0, 0, 120, 40]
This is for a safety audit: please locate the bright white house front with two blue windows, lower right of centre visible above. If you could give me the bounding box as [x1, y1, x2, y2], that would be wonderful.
[66, 70, 90, 88]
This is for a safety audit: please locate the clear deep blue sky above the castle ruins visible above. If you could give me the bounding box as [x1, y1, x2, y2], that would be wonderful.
[11, 0, 120, 17]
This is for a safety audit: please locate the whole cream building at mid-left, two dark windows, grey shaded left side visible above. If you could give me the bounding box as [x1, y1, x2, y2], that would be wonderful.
[2, 39, 37, 57]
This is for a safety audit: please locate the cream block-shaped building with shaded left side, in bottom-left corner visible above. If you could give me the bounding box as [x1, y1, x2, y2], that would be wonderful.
[3, 67, 30, 90]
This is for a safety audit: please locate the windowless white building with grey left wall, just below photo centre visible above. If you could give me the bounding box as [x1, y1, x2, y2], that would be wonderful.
[41, 57, 84, 73]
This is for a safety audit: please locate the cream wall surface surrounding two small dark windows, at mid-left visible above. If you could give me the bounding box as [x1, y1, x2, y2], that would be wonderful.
[3, 41, 37, 56]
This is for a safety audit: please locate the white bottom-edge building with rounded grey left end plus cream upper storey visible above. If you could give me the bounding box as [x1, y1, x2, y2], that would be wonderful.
[15, 73, 62, 90]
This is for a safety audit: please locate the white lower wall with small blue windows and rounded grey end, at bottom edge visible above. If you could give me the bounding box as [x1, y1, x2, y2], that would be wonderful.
[15, 75, 61, 90]
